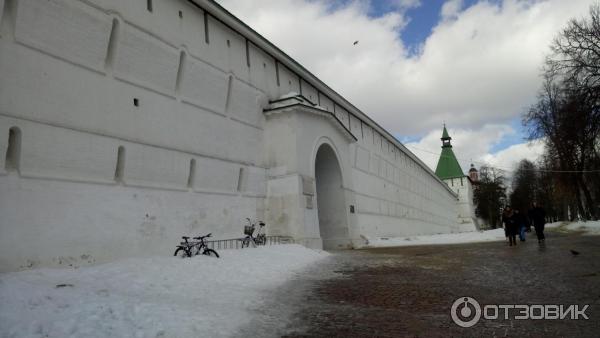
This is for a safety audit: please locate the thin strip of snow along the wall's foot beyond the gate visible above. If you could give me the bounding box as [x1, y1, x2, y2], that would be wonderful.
[365, 229, 505, 248]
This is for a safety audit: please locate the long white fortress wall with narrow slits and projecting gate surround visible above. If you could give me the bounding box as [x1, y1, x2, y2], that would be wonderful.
[0, 0, 460, 270]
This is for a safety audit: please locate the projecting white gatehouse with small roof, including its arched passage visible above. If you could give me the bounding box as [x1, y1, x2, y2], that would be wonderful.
[265, 96, 357, 249]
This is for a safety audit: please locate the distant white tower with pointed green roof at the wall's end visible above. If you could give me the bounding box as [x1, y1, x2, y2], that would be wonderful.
[435, 125, 478, 231]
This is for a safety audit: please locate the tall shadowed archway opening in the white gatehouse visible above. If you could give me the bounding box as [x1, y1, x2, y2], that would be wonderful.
[315, 144, 349, 249]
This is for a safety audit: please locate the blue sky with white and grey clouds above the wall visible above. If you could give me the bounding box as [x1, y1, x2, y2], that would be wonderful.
[217, 0, 594, 171]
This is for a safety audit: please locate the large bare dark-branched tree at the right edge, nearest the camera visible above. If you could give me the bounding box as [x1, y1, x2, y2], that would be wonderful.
[523, 4, 600, 219]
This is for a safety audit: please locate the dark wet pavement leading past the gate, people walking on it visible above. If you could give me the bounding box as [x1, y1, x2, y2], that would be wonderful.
[236, 232, 600, 337]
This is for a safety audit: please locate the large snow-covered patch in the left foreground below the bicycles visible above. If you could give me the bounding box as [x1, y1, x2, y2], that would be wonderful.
[0, 245, 328, 337]
